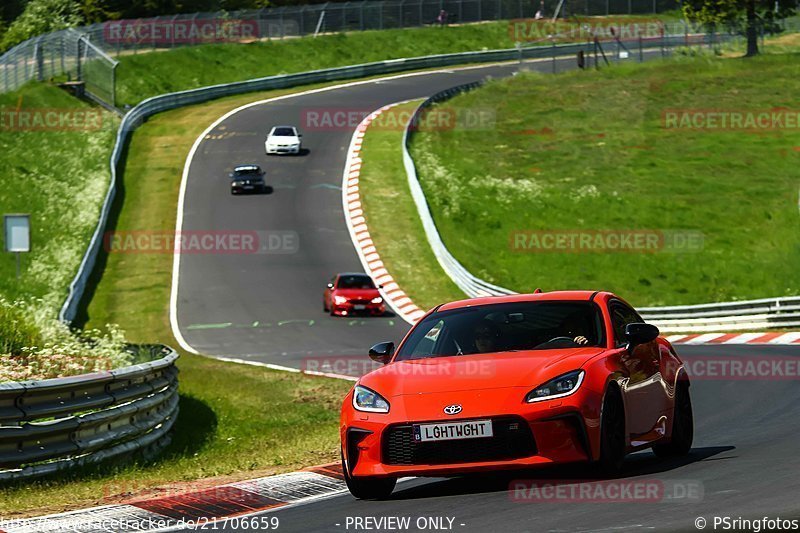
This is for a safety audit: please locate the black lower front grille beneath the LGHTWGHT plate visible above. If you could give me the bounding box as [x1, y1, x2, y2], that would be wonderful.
[381, 416, 536, 465]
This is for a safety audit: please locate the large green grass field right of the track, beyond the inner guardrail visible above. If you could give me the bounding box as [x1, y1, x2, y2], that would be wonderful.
[406, 52, 800, 305]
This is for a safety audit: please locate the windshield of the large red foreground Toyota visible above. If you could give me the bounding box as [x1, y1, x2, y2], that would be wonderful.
[397, 302, 605, 360]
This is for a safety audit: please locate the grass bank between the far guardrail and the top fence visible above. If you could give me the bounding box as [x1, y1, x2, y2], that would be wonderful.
[117, 14, 675, 105]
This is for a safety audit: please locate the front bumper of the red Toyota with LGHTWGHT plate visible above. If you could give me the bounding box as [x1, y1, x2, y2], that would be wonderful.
[340, 386, 599, 477]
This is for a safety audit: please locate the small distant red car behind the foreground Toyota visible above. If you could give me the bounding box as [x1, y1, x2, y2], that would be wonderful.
[322, 272, 386, 316]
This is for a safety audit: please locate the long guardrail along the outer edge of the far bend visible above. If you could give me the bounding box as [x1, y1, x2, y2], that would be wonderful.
[59, 34, 706, 322]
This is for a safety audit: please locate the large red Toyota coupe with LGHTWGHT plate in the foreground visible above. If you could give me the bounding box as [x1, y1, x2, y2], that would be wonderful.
[340, 291, 694, 499]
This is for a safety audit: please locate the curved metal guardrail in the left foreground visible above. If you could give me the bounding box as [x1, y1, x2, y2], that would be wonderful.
[0, 346, 178, 482]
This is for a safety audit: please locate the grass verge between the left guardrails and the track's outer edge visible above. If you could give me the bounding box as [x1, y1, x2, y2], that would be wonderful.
[0, 87, 351, 518]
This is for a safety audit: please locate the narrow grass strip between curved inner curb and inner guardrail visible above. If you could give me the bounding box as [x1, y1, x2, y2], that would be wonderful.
[359, 101, 464, 310]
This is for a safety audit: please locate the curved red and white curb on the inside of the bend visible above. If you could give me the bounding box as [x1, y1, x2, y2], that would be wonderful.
[342, 102, 432, 324]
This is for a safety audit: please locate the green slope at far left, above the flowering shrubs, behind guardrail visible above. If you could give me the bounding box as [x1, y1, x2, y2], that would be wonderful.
[0, 83, 119, 314]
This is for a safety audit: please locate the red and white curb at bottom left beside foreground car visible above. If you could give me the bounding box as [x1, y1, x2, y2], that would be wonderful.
[0, 464, 347, 533]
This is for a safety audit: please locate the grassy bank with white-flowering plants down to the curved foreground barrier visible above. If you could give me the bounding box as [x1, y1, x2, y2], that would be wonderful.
[0, 83, 130, 382]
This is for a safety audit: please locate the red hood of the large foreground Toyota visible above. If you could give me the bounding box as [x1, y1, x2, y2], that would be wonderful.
[360, 347, 604, 399]
